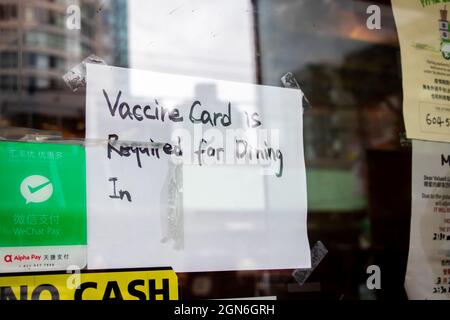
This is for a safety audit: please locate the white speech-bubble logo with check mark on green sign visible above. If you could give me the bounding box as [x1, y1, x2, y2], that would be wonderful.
[20, 175, 53, 204]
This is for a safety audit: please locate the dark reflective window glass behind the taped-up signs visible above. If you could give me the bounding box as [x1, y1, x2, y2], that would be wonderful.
[0, 0, 426, 300]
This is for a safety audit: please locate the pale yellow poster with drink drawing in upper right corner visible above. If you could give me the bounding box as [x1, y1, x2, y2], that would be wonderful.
[392, 0, 450, 142]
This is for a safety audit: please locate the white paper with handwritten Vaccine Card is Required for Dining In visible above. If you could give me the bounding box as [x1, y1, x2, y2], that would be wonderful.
[86, 65, 310, 272]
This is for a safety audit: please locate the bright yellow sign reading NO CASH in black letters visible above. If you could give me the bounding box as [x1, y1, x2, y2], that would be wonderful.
[0, 268, 178, 300]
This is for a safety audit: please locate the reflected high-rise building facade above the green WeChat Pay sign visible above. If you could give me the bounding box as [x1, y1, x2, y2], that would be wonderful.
[0, 0, 128, 137]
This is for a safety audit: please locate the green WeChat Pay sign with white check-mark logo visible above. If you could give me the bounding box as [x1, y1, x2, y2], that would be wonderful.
[0, 142, 87, 247]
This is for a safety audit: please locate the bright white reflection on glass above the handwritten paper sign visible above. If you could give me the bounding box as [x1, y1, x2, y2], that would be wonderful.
[128, 0, 256, 82]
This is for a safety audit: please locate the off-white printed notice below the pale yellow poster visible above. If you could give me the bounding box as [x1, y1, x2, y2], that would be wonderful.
[405, 140, 450, 300]
